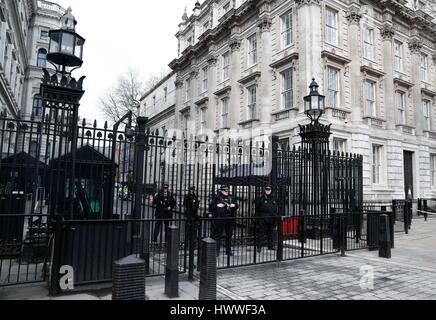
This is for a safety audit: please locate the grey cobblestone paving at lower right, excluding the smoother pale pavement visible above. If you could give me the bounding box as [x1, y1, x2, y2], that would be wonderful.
[218, 255, 436, 300]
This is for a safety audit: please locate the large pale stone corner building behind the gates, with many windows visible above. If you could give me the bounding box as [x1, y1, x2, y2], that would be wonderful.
[142, 0, 436, 201]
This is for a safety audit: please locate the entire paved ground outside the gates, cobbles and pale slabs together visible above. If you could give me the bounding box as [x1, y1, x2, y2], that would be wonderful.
[0, 219, 436, 301]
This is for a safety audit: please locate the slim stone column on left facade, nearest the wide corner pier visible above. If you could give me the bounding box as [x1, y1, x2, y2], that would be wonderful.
[257, 15, 273, 127]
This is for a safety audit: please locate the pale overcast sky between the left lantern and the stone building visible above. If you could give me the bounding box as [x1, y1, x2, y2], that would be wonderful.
[52, 0, 196, 120]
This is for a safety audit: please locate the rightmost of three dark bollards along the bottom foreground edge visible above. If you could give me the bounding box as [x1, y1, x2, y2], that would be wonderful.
[199, 238, 217, 301]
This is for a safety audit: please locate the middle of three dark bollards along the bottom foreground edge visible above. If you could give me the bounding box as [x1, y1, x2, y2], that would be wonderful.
[165, 225, 179, 298]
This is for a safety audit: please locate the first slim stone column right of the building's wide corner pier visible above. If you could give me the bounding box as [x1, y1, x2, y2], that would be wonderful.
[346, 6, 363, 123]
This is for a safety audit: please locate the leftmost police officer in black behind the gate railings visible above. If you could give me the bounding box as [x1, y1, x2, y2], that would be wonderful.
[153, 184, 176, 242]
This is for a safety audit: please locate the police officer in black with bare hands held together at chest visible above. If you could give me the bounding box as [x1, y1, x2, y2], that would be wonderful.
[209, 186, 239, 256]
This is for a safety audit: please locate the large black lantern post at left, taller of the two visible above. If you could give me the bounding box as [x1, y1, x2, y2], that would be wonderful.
[40, 8, 85, 219]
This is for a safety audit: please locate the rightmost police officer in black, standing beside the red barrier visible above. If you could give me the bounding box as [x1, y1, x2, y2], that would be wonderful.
[256, 186, 278, 252]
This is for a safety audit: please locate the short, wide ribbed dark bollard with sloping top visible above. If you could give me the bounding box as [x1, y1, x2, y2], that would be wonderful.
[112, 256, 145, 300]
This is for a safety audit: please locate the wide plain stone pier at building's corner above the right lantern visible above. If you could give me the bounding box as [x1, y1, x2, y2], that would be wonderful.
[296, 0, 325, 113]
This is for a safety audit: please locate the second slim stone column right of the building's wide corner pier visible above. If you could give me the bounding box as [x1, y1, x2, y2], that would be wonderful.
[380, 22, 397, 130]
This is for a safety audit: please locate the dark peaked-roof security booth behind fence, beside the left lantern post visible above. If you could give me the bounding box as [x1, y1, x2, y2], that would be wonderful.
[50, 145, 119, 220]
